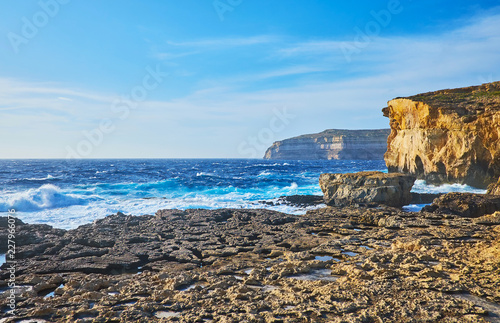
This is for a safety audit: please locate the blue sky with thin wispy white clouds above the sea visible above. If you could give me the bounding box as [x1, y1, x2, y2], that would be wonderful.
[0, 0, 500, 159]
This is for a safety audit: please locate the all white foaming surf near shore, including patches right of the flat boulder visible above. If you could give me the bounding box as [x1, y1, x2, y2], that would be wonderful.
[0, 178, 484, 229]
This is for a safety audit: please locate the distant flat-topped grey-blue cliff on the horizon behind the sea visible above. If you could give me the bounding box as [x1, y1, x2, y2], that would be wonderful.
[264, 129, 391, 160]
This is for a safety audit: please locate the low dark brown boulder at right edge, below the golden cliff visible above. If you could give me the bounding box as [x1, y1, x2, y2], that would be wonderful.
[422, 193, 500, 218]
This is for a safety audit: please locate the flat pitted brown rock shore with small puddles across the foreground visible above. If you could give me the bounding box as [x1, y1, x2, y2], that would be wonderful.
[0, 194, 500, 322]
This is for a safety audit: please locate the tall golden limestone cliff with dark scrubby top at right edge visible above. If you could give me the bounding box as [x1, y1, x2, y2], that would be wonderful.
[382, 82, 500, 188]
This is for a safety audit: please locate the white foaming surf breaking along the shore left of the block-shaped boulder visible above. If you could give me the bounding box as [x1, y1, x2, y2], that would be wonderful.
[4, 183, 320, 229]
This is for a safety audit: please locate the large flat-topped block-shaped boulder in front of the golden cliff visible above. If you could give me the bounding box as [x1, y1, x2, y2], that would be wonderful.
[319, 172, 415, 207]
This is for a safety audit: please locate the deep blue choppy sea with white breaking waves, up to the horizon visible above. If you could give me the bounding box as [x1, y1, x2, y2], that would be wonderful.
[0, 159, 485, 229]
